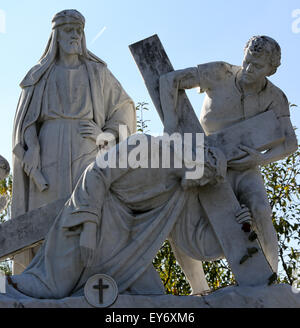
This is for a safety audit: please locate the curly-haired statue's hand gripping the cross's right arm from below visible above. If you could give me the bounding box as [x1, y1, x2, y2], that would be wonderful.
[227, 145, 263, 171]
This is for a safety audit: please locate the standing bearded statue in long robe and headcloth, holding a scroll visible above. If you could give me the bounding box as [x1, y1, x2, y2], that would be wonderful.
[12, 10, 136, 274]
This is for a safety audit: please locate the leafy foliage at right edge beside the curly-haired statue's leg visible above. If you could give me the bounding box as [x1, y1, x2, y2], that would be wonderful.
[262, 149, 300, 284]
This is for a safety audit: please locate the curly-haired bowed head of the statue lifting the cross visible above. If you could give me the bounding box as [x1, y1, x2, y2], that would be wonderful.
[242, 36, 281, 83]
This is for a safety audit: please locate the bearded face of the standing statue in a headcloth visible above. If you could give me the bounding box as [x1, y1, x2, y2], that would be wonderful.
[58, 23, 83, 55]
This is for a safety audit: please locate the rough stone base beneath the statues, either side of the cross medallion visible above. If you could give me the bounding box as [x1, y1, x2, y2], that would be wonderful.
[0, 284, 300, 308]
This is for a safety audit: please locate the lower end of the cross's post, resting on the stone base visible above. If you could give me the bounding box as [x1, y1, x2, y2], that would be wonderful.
[199, 183, 273, 286]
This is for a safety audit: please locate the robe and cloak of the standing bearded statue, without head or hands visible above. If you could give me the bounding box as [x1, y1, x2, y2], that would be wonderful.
[12, 60, 136, 217]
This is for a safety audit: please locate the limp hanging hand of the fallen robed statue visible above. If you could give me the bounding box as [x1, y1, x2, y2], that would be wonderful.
[79, 222, 97, 267]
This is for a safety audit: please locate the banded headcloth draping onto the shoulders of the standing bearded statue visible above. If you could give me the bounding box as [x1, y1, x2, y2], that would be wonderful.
[20, 9, 106, 88]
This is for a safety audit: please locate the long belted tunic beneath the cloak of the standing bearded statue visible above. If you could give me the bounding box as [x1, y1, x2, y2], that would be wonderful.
[28, 64, 97, 209]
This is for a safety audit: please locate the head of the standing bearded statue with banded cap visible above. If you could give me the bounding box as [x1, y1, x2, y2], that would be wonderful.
[52, 9, 85, 55]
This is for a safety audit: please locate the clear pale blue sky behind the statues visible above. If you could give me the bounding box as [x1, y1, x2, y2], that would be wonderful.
[0, 0, 300, 162]
